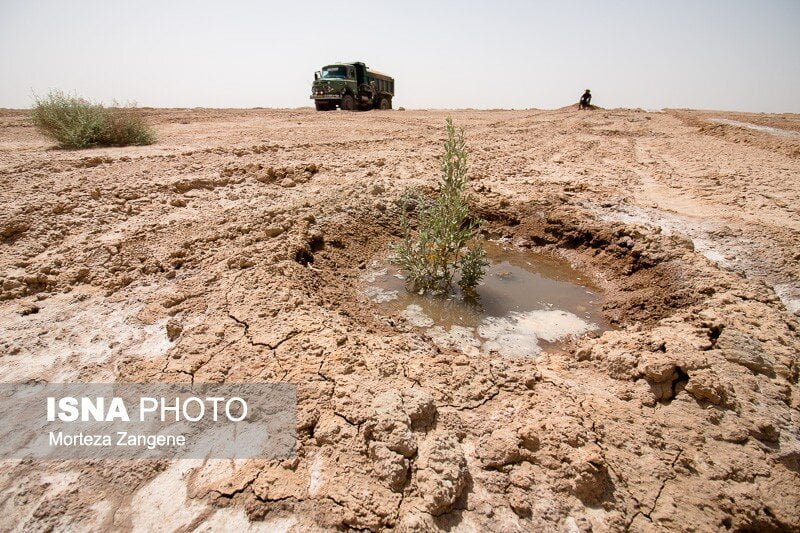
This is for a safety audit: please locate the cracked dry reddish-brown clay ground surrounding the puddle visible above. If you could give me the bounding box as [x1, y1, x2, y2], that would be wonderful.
[0, 109, 800, 531]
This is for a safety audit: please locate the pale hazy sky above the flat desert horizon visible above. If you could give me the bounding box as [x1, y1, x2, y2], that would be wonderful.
[0, 0, 800, 112]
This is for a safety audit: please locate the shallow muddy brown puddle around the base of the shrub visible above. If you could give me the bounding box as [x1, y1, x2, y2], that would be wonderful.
[362, 242, 609, 357]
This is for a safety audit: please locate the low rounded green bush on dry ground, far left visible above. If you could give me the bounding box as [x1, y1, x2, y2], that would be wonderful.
[32, 91, 155, 148]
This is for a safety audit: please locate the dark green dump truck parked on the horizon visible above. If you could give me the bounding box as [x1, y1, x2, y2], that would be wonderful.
[311, 61, 394, 111]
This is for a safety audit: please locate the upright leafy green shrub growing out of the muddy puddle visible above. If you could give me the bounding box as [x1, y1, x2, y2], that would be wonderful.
[392, 118, 488, 295]
